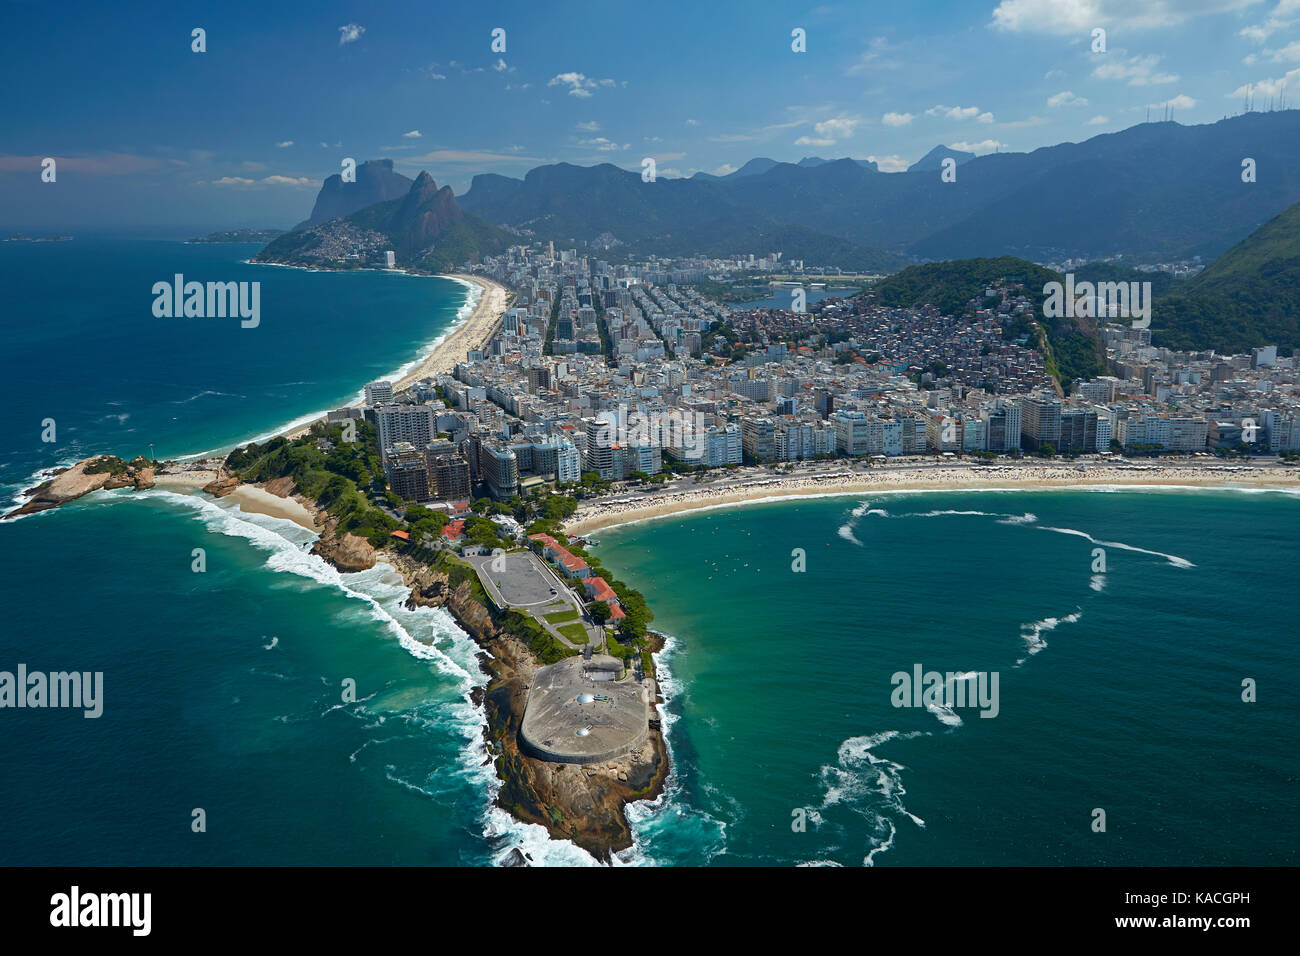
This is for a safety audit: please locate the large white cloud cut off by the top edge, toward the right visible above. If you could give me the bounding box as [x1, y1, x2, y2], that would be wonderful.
[989, 0, 1258, 39]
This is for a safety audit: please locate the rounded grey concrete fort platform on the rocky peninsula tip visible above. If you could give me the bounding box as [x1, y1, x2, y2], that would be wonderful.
[519, 654, 650, 763]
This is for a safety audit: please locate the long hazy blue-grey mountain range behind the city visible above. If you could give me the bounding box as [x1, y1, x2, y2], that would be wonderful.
[459, 111, 1300, 268]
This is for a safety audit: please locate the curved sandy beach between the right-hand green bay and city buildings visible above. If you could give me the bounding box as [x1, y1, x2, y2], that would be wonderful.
[564, 463, 1300, 535]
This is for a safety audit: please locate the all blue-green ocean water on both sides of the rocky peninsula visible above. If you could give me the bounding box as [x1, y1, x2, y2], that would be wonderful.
[0, 239, 1300, 866]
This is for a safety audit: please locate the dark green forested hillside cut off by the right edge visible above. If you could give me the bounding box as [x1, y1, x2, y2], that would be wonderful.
[1152, 203, 1300, 352]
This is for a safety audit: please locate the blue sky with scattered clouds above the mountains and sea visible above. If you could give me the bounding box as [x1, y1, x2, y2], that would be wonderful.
[0, 0, 1300, 232]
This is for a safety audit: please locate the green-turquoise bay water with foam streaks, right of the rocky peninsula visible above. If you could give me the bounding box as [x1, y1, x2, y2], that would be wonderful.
[597, 492, 1300, 865]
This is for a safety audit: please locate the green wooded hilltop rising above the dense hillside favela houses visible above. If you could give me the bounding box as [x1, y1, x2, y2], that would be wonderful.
[872, 256, 1106, 388]
